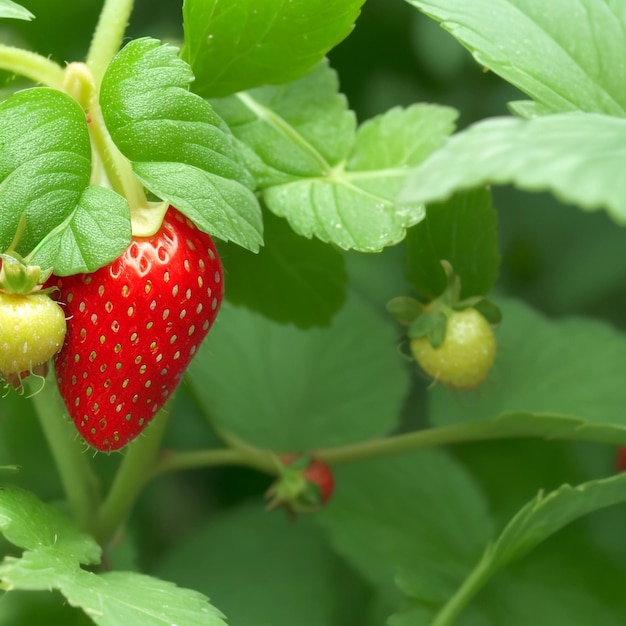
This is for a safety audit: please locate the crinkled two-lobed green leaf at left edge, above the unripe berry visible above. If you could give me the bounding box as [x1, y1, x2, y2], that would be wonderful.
[0, 87, 130, 274]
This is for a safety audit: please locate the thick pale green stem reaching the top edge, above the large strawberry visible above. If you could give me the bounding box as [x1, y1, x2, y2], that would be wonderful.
[87, 0, 134, 85]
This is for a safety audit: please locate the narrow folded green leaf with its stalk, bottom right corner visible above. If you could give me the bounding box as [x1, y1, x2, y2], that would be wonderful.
[422, 473, 626, 626]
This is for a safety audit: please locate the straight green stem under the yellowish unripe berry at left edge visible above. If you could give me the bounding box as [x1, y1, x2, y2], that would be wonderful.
[32, 372, 99, 530]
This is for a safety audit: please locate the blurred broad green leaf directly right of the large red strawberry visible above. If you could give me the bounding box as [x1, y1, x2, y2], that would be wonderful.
[188, 296, 409, 451]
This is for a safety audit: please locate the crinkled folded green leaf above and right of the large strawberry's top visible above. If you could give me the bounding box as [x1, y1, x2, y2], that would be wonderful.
[100, 38, 262, 251]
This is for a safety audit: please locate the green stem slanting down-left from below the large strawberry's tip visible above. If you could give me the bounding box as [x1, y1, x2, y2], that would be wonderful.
[95, 409, 168, 545]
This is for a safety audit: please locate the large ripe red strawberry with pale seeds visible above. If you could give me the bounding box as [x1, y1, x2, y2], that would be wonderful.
[54, 207, 223, 451]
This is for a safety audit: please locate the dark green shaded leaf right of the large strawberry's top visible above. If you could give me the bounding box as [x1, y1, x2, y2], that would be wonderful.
[220, 212, 346, 328]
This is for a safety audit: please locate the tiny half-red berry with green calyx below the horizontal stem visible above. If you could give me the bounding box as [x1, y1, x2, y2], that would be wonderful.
[265, 454, 334, 515]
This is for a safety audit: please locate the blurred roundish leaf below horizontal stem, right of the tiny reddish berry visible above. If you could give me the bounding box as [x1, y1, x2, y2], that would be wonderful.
[319, 450, 492, 608]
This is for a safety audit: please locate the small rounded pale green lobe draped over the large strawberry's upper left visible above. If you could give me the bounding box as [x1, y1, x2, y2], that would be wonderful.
[31, 186, 131, 276]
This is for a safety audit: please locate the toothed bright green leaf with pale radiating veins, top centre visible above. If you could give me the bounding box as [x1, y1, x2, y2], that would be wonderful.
[214, 63, 456, 252]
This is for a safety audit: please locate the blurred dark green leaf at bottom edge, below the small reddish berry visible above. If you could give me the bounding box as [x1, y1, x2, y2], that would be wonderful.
[158, 501, 366, 626]
